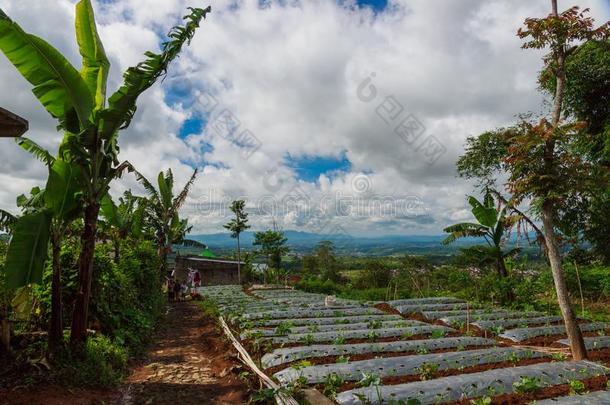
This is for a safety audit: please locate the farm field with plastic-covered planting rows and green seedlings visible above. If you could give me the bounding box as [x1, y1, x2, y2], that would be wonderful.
[200, 286, 610, 405]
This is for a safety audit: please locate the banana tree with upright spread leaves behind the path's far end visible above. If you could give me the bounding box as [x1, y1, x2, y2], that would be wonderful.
[135, 169, 197, 274]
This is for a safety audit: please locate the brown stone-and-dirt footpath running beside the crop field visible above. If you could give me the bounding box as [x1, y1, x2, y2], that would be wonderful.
[120, 302, 248, 405]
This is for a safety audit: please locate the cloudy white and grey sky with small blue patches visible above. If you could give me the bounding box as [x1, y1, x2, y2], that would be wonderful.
[0, 0, 610, 236]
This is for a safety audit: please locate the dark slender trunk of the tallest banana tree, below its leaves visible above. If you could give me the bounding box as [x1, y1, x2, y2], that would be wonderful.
[70, 203, 100, 355]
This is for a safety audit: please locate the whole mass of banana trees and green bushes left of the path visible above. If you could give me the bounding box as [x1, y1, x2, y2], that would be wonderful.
[0, 0, 210, 385]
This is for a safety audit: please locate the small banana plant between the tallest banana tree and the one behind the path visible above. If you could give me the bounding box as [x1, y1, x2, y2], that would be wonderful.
[101, 190, 146, 263]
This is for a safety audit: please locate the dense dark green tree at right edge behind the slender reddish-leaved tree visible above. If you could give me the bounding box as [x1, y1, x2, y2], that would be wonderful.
[539, 40, 610, 263]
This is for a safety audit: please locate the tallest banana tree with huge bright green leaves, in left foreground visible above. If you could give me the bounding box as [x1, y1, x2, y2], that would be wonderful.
[0, 0, 211, 354]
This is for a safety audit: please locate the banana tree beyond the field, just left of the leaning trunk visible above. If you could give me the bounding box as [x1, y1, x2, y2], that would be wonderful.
[442, 193, 519, 277]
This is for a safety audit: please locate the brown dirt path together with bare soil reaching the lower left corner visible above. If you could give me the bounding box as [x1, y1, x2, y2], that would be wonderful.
[0, 302, 249, 405]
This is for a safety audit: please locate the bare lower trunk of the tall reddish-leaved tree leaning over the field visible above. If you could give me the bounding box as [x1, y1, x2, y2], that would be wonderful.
[542, 201, 587, 360]
